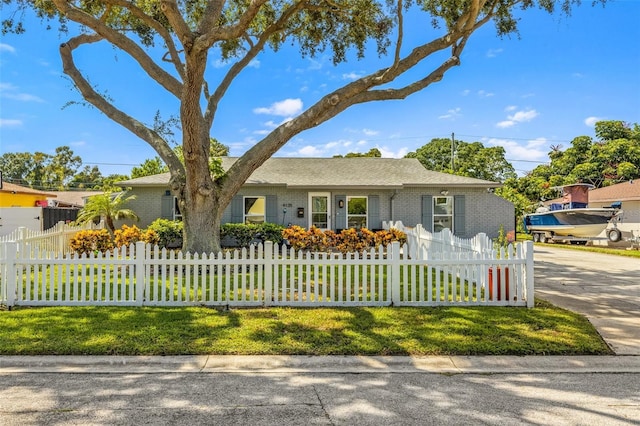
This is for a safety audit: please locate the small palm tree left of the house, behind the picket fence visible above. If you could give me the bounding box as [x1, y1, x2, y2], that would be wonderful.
[76, 191, 139, 234]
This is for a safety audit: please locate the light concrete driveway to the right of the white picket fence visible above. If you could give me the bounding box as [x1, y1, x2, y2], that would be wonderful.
[534, 245, 640, 355]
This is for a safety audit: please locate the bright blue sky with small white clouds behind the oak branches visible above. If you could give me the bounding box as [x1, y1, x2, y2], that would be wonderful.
[0, 0, 640, 180]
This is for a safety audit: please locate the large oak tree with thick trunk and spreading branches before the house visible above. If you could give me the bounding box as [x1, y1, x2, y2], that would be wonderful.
[3, 0, 604, 252]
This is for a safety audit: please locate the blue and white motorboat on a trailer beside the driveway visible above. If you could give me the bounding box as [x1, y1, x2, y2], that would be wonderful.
[524, 183, 622, 243]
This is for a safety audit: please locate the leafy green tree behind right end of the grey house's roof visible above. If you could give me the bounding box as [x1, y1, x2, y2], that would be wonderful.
[405, 138, 516, 182]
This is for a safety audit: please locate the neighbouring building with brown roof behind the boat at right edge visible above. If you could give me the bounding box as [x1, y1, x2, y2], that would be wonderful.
[589, 180, 640, 243]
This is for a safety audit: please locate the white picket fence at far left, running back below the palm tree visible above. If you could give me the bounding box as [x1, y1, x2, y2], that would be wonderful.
[0, 221, 105, 255]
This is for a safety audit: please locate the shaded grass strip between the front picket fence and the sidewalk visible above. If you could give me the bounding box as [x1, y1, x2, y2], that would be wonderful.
[0, 300, 612, 355]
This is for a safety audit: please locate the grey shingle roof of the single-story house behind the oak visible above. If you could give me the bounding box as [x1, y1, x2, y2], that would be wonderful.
[119, 157, 500, 188]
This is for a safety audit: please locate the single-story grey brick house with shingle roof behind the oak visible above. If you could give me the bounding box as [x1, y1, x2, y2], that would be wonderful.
[118, 157, 515, 237]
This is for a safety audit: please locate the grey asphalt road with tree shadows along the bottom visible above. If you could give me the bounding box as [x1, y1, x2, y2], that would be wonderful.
[0, 373, 640, 426]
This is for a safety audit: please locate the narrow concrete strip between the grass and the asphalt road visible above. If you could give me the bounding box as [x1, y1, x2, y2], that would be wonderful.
[0, 355, 640, 374]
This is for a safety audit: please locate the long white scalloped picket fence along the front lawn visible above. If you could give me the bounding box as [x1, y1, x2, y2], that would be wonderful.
[0, 236, 533, 307]
